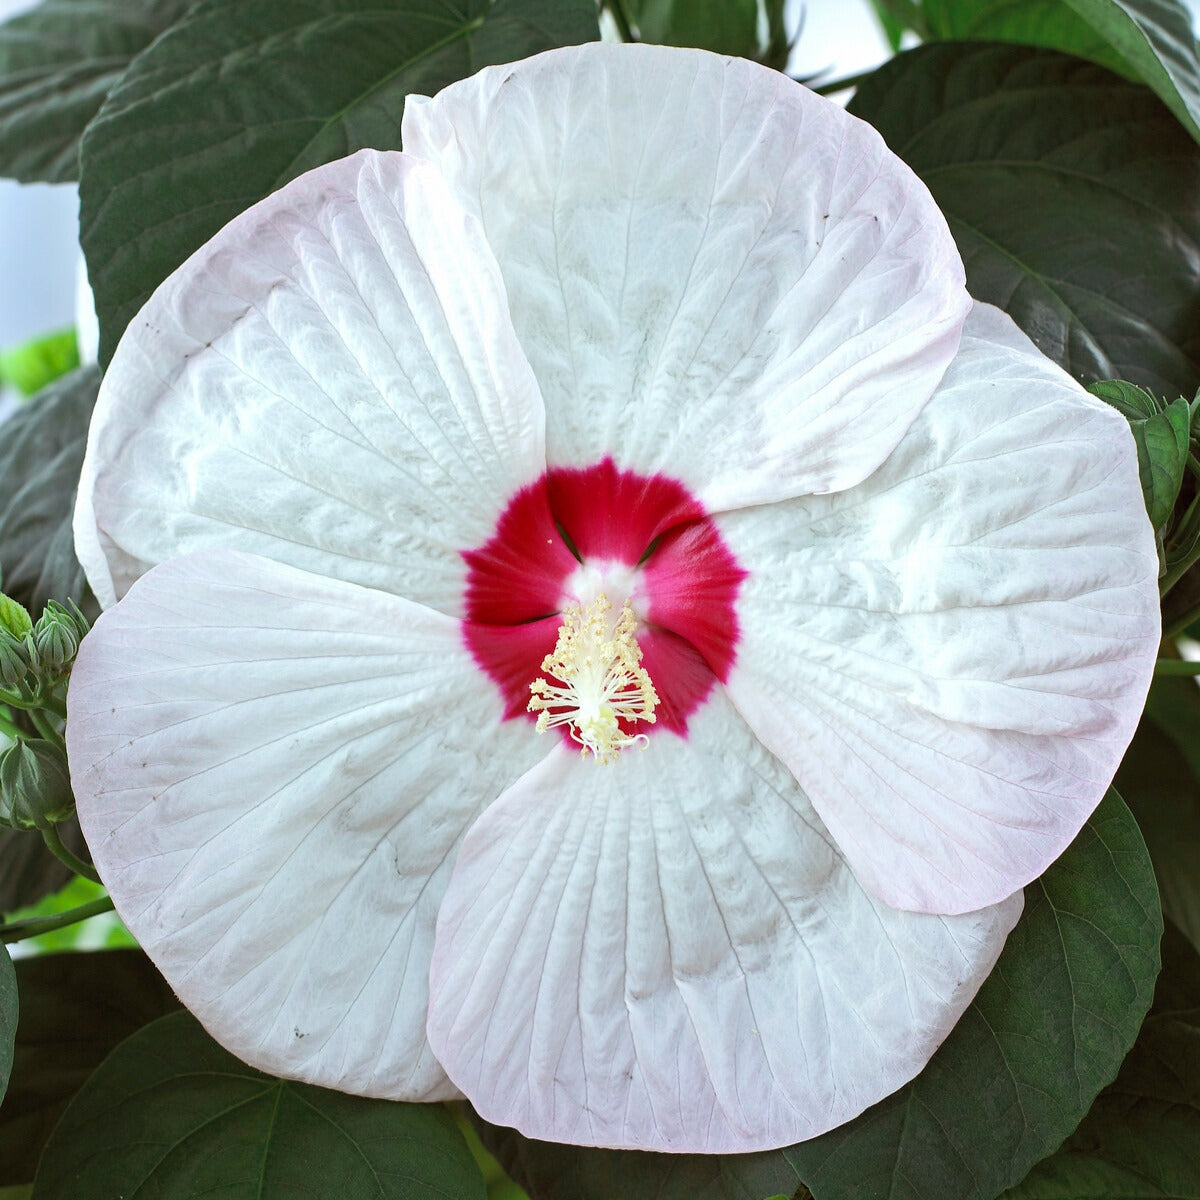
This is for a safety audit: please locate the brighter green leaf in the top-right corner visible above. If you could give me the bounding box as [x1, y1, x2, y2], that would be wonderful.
[922, 0, 1200, 147]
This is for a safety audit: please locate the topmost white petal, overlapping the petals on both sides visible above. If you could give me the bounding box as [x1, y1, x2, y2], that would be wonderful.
[403, 43, 970, 509]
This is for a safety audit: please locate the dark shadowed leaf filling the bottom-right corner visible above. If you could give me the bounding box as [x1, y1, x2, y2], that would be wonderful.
[1006, 926, 1200, 1200]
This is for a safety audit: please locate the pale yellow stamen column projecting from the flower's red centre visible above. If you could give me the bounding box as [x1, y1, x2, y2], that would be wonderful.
[528, 592, 659, 763]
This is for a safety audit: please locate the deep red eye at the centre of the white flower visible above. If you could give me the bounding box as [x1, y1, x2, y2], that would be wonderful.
[463, 458, 745, 736]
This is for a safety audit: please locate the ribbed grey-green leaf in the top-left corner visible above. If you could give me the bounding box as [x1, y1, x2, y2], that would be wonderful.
[0, 0, 194, 184]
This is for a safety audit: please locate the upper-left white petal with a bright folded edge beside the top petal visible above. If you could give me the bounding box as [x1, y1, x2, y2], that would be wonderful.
[76, 151, 545, 612]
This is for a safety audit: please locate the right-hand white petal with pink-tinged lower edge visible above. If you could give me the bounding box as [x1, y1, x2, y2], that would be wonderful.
[719, 306, 1159, 912]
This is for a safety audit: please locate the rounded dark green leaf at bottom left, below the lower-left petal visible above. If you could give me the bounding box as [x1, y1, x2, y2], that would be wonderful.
[34, 1013, 485, 1200]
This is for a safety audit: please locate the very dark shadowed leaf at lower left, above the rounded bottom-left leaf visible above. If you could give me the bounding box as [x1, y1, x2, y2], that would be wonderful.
[0, 950, 179, 1184]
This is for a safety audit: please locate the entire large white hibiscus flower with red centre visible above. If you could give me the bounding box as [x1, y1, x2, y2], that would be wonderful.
[67, 44, 1158, 1152]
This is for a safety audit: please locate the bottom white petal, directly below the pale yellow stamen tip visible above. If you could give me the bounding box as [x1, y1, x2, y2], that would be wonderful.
[430, 691, 1021, 1153]
